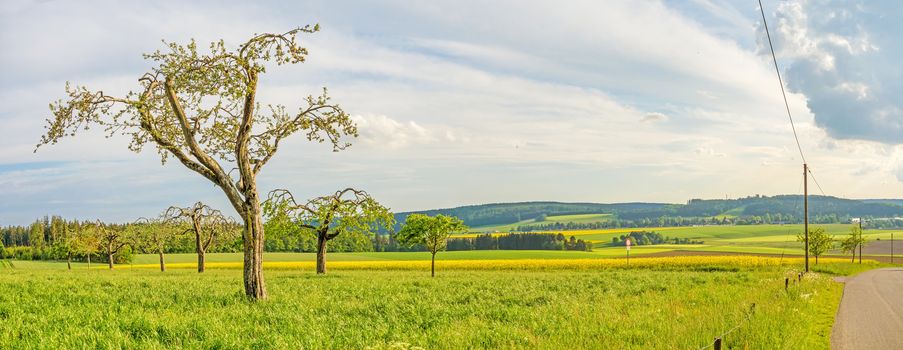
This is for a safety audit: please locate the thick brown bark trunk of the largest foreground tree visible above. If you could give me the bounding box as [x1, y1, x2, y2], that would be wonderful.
[243, 205, 267, 300]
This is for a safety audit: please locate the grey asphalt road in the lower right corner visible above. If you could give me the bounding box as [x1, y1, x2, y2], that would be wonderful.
[831, 268, 903, 350]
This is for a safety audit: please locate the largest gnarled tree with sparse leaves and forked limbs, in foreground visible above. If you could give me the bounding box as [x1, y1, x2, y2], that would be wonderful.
[38, 26, 357, 300]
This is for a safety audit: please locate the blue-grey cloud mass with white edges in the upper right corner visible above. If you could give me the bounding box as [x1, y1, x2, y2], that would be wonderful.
[760, 0, 903, 144]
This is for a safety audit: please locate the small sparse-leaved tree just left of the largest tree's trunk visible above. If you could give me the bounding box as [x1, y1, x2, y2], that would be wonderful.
[163, 202, 236, 272]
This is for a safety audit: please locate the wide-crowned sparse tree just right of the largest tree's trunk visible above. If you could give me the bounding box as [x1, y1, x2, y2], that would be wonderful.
[264, 188, 395, 274]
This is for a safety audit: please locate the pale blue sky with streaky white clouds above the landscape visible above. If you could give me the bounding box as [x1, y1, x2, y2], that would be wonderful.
[0, 0, 903, 225]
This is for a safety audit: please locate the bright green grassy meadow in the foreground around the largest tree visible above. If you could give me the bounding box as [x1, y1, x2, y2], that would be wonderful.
[0, 258, 876, 349]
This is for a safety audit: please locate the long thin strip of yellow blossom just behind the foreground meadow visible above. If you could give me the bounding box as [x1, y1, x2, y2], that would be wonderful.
[124, 256, 877, 270]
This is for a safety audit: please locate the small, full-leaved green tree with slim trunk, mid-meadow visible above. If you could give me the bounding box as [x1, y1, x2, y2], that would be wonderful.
[395, 214, 467, 277]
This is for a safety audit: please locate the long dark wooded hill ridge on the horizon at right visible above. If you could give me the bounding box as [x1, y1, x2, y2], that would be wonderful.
[396, 195, 903, 232]
